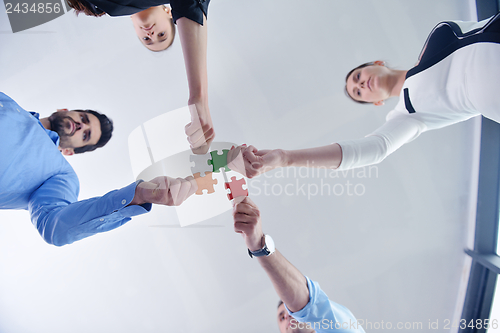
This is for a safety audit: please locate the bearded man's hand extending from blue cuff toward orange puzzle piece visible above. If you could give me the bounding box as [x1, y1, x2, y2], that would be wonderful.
[130, 176, 198, 206]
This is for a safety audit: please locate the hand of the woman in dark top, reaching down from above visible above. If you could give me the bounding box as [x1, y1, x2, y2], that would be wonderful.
[185, 102, 215, 154]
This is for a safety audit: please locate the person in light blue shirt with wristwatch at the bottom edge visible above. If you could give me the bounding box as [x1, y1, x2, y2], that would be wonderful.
[233, 197, 364, 333]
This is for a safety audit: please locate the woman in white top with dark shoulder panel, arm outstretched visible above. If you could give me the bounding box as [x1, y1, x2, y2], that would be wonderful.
[230, 14, 500, 177]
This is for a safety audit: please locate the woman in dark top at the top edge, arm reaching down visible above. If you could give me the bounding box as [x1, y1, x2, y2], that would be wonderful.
[67, 0, 215, 154]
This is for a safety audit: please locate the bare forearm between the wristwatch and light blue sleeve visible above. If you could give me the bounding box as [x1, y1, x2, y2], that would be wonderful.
[258, 250, 309, 312]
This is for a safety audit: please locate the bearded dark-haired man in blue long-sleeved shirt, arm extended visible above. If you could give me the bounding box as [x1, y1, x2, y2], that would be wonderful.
[0, 93, 197, 246]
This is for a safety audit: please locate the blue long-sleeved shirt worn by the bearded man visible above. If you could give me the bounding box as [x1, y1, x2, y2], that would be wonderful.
[0, 92, 151, 246]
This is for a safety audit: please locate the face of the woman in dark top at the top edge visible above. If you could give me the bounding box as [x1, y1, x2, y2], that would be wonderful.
[130, 6, 175, 51]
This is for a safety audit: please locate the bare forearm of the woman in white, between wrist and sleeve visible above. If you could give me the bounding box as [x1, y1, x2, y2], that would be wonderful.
[283, 143, 342, 169]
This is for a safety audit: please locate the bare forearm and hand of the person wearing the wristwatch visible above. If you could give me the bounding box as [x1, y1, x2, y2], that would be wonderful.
[233, 197, 309, 312]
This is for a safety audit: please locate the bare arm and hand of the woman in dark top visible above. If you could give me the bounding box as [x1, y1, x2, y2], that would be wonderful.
[177, 16, 215, 154]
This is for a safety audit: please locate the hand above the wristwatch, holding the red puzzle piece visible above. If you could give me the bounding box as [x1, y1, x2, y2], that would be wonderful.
[233, 197, 264, 251]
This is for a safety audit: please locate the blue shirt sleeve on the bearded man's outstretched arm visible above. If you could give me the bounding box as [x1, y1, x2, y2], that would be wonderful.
[28, 173, 151, 246]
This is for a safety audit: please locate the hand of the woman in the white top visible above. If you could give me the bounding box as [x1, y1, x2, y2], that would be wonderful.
[227, 145, 287, 178]
